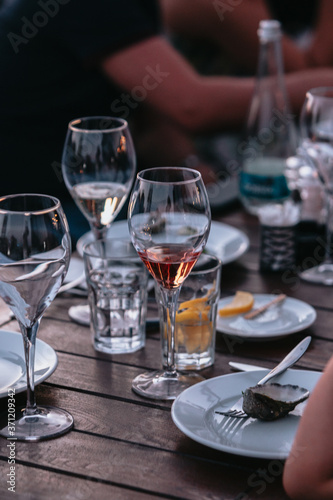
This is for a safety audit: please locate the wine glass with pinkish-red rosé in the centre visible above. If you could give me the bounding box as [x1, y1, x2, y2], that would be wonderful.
[128, 167, 211, 399]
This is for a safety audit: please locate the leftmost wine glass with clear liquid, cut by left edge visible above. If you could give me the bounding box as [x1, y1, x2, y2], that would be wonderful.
[0, 194, 73, 441]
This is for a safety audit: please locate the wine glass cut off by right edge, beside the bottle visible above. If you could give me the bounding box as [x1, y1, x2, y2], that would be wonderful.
[300, 87, 333, 285]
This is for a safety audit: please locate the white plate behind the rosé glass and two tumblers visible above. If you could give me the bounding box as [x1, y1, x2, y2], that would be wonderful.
[76, 220, 249, 264]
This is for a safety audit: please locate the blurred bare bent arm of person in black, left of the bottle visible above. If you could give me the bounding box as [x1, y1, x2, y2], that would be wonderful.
[102, 37, 254, 133]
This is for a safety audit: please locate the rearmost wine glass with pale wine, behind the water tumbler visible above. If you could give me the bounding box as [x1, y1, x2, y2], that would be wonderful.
[62, 116, 136, 321]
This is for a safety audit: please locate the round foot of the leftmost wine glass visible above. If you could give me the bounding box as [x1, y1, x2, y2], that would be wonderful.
[0, 406, 74, 441]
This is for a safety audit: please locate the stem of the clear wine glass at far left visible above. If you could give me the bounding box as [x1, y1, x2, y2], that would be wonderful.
[20, 320, 40, 415]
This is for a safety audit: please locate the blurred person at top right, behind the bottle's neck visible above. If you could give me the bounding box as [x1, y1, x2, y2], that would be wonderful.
[160, 0, 333, 74]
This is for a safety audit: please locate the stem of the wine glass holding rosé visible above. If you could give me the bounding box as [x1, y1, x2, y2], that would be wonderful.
[161, 287, 180, 376]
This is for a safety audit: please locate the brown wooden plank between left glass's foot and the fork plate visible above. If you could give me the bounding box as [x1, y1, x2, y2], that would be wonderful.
[0, 384, 276, 473]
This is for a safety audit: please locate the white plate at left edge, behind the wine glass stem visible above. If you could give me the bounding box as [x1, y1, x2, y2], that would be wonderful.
[0, 330, 58, 398]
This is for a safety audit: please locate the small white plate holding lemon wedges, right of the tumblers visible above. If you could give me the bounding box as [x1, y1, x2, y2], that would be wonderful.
[216, 294, 317, 340]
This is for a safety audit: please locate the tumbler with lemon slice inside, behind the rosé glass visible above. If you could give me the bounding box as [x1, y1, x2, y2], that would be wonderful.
[156, 254, 221, 370]
